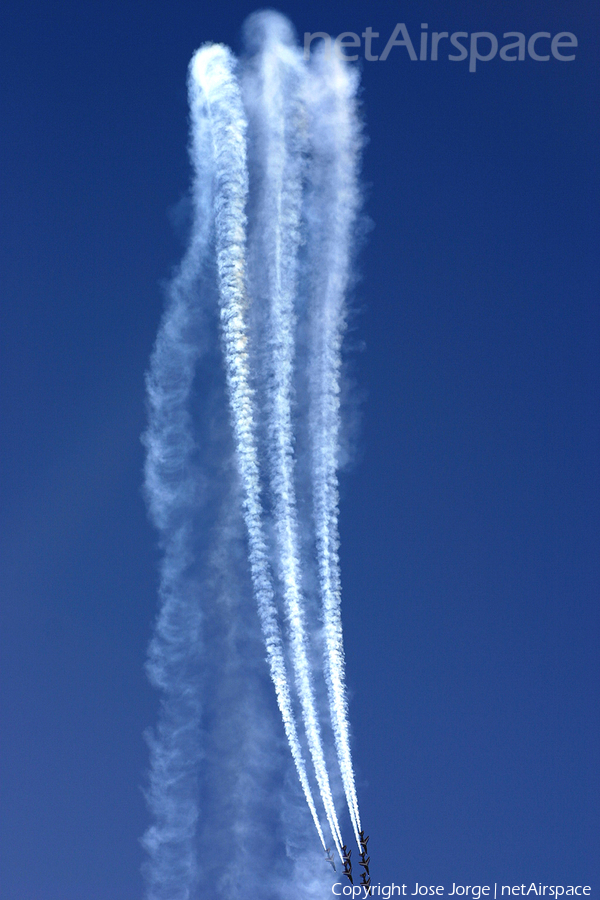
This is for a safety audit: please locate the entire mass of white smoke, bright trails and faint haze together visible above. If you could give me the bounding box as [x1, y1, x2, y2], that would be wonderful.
[143, 13, 361, 900]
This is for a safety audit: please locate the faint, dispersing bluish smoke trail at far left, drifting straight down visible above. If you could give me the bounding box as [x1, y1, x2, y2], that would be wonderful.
[143, 63, 213, 900]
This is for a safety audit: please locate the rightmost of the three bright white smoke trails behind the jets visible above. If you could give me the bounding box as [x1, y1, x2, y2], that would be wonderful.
[307, 56, 361, 846]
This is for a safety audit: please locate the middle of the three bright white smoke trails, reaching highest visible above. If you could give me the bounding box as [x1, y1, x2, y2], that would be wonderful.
[244, 13, 343, 856]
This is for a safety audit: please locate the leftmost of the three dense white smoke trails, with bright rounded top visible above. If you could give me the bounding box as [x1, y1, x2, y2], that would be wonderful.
[191, 45, 325, 847]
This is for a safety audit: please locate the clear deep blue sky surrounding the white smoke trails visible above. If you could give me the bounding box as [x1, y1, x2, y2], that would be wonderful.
[0, 0, 600, 900]
